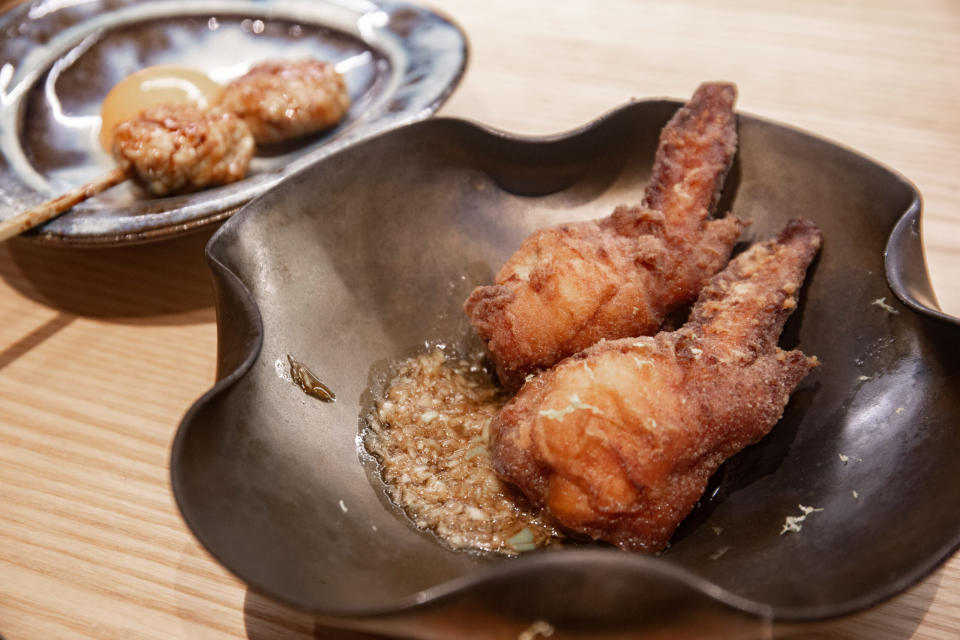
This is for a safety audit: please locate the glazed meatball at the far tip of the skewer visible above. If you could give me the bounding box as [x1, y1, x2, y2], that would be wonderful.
[220, 59, 350, 143]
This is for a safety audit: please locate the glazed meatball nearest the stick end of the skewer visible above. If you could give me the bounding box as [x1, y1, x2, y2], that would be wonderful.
[113, 104, 254, 195]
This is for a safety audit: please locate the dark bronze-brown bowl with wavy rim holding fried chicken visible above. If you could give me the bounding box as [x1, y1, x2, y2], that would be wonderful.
[171, 101, 960, 638]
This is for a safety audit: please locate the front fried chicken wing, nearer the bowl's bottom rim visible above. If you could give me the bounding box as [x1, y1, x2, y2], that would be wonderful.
[491, 219, 820, 552]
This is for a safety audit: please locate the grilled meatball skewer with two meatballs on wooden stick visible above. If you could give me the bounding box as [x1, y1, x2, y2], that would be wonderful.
[0, 60, 350, 242]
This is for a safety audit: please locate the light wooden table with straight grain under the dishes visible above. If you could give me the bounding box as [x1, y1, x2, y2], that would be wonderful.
[0, 0, 960, 640]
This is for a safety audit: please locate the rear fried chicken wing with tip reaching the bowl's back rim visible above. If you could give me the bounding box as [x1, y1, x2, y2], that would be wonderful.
[464, 83, 742, 388]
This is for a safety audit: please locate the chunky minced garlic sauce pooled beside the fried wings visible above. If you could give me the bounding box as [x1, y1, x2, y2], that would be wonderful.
[364, 349, 561, 555]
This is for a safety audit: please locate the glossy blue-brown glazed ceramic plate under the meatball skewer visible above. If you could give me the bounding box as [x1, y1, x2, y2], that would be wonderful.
[0, 0, 467, 244]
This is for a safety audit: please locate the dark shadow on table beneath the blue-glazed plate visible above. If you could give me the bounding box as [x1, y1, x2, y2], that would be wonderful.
[0, 228, 215, 324]
